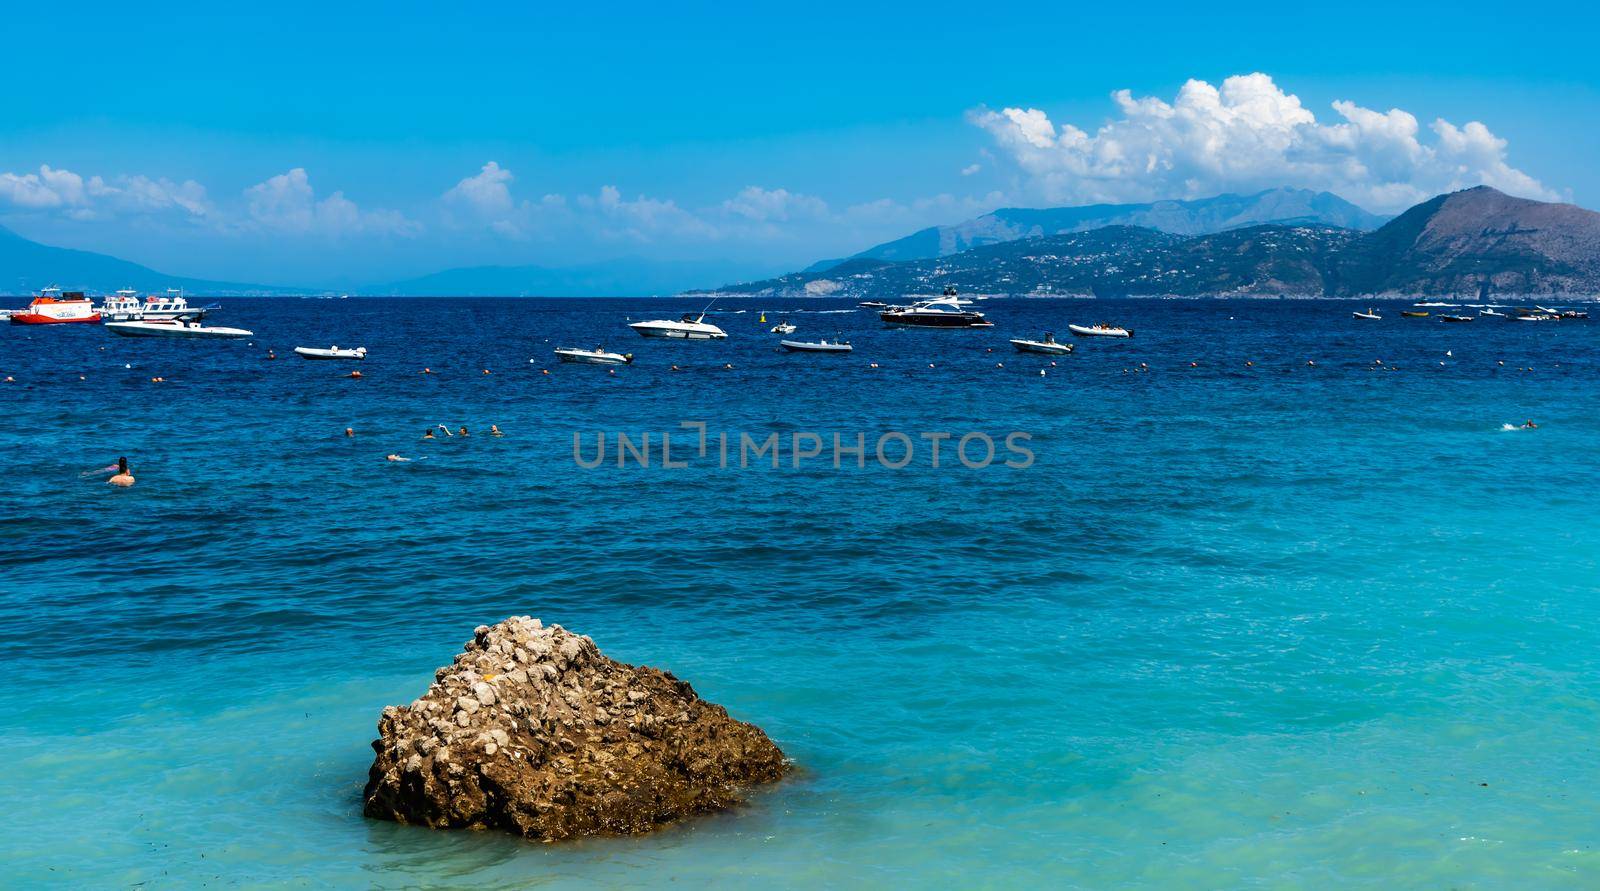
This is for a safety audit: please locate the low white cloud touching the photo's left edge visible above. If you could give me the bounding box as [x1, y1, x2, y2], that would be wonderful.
[0, 165, 211, 219]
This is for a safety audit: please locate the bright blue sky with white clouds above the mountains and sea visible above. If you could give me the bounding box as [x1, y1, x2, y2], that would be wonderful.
[0, 0, 1600, 288]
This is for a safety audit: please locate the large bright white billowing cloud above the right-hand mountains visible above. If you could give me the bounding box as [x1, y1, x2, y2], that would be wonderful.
[968, 74, 1560, 211]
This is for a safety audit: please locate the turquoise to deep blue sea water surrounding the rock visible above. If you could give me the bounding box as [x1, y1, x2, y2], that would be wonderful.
[0, 299, 1600, 888]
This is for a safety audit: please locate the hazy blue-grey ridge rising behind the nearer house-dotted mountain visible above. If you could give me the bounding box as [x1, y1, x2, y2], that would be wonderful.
[802, 189, 1386, 274]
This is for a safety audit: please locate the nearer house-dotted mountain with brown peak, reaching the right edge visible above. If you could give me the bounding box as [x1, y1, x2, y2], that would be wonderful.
[717, 187, 1600, 299]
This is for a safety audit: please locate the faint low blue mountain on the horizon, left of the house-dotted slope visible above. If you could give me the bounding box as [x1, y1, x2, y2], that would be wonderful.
[376, 259, 774, 298]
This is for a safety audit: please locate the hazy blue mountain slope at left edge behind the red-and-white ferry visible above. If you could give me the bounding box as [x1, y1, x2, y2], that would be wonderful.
[0, 226, 294, 294]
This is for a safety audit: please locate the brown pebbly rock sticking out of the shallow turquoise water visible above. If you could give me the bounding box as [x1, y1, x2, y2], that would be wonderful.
[363, 616, 787, 840]
